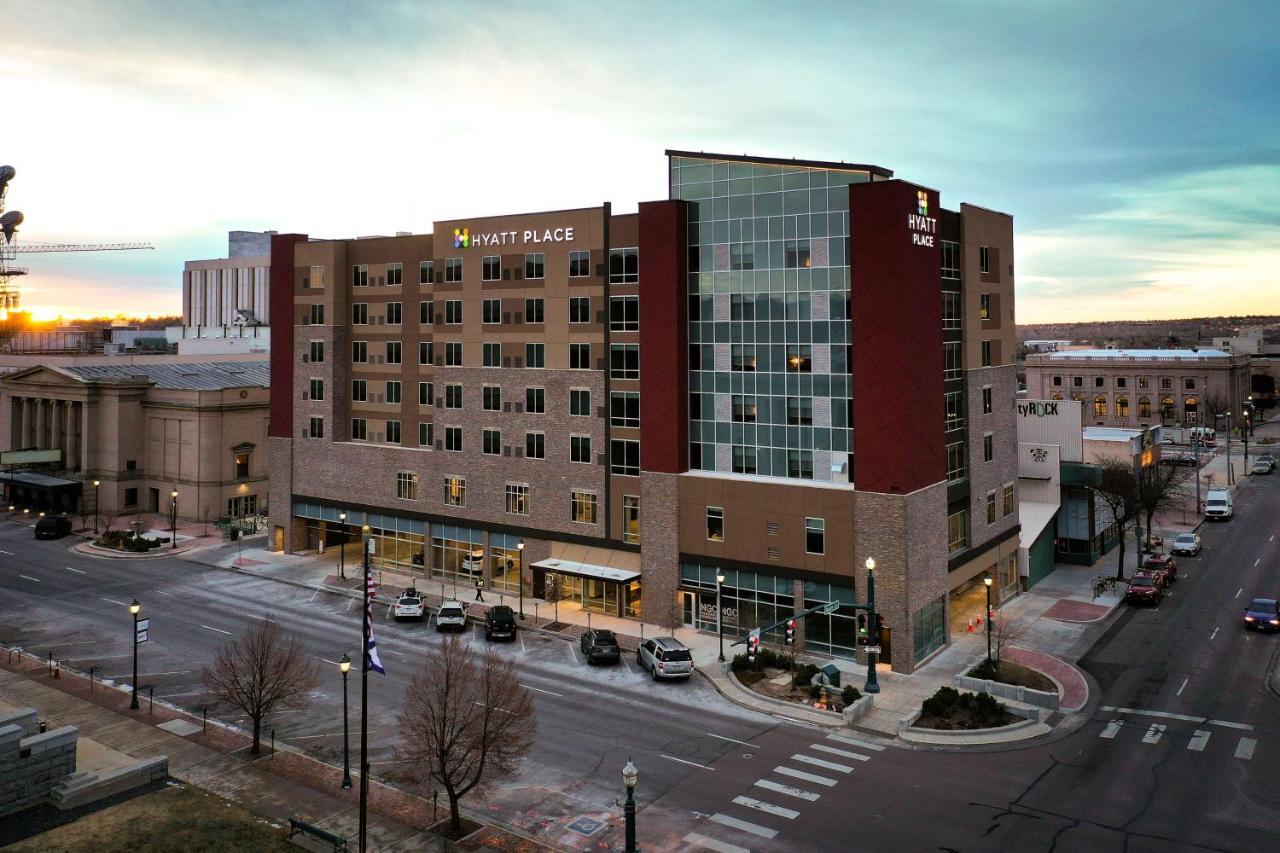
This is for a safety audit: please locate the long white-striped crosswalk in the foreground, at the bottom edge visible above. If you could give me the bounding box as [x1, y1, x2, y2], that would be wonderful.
[684, 734, 884, 853]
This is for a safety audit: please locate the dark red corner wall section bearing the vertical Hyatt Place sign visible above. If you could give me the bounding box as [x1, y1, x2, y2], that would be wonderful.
[849, 181, 946, 494]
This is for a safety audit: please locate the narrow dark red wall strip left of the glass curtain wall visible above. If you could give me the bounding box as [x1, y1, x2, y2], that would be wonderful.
[640, 201, 689, 474]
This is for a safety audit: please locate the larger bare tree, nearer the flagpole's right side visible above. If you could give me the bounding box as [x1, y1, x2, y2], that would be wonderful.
[396, 637, 538, 833]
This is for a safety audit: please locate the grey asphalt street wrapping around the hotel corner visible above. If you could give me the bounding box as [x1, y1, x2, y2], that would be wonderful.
[0, 466, 1280, 852]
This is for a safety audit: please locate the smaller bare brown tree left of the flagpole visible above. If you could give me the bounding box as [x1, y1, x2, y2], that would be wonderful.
[201, 613, 320, 756]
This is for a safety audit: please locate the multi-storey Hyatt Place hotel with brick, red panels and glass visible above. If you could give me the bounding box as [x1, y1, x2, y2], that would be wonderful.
[269, 151, 1018, 671]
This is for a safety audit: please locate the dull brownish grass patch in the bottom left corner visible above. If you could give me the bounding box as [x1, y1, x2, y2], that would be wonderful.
[6, 785, 298, 853]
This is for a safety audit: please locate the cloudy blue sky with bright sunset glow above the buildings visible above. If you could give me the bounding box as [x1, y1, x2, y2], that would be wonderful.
[0, 0, 1280, 323]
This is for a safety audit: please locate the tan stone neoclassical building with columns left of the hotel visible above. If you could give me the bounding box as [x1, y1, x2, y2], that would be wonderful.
[0, 360, 269, 520]
